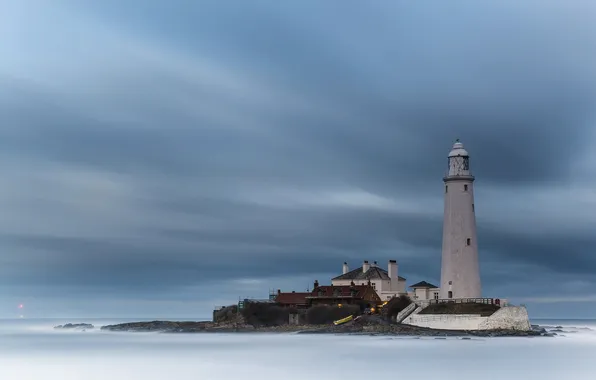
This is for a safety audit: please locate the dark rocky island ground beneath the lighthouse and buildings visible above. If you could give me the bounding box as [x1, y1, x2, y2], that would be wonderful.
[96, 299, 555, 337]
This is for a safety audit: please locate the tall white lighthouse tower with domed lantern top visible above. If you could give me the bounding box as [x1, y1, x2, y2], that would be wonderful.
[440, 140, 482, 299]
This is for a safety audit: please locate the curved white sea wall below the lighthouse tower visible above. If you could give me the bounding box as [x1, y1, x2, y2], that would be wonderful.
[403, 306, 531, 331]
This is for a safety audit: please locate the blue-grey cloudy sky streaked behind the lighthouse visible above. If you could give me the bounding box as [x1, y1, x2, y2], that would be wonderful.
[0, 0, 596, 318]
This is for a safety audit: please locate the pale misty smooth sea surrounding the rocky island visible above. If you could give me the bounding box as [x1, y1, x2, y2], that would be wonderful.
[0, 319, 596, 380]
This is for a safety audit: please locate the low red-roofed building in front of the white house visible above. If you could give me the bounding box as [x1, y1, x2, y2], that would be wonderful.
[306, 281, 382, 306]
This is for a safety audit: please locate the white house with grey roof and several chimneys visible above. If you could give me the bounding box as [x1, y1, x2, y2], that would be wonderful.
[331, 260, 407, 300]
